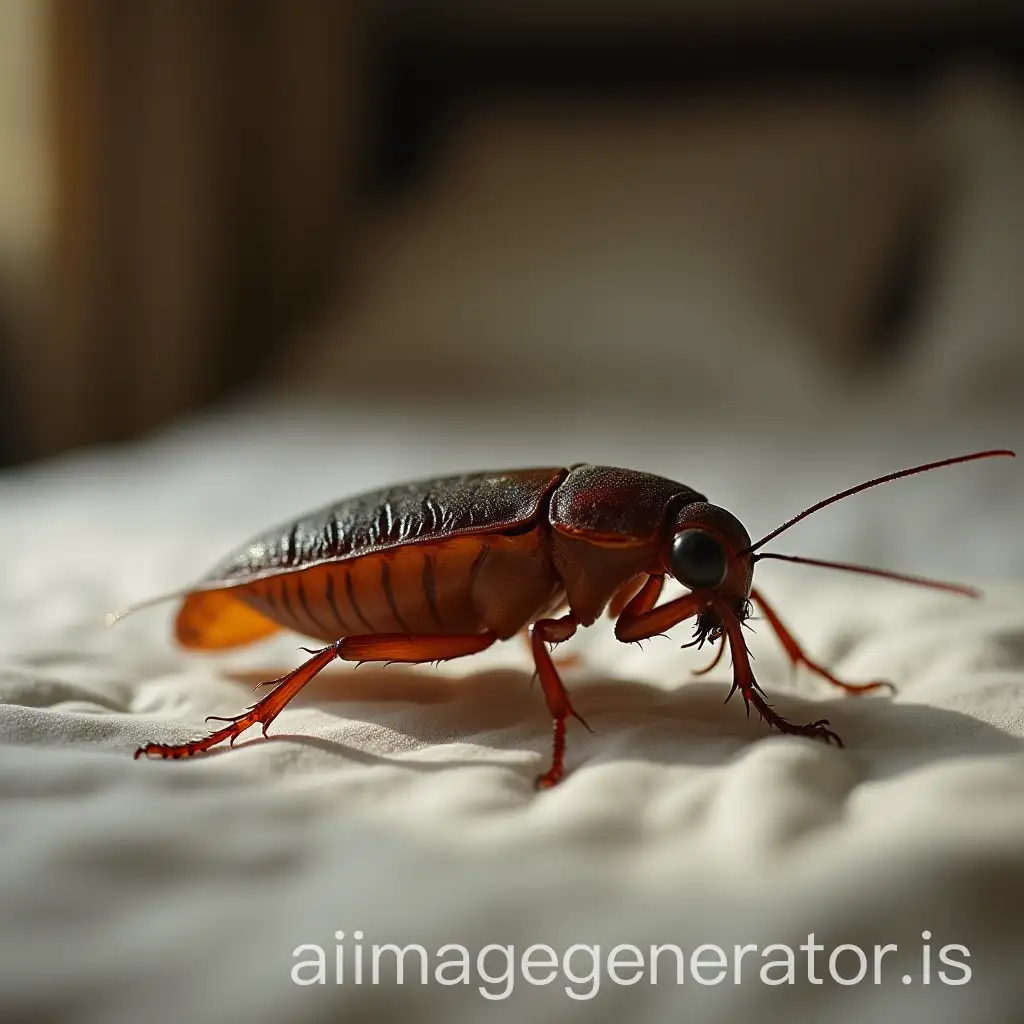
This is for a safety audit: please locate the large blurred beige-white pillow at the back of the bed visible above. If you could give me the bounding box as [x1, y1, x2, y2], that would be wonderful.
[285, 98, 924, 406]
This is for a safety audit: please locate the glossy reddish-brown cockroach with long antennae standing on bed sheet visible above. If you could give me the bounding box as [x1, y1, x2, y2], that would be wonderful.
[114, 449, 1014, 788]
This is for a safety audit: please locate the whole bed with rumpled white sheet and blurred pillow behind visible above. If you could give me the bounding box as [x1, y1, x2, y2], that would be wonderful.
[0, 83, 1024, 1024]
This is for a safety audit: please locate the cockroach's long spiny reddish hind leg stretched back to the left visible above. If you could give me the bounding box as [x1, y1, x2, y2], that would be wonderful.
[135, 633, 498, 758]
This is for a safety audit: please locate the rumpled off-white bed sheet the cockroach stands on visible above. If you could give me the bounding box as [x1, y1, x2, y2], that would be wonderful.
[0, 402, 1024, 1024]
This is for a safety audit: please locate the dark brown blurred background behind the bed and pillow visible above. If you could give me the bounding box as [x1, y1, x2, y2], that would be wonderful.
[0, 0, 1024, 463]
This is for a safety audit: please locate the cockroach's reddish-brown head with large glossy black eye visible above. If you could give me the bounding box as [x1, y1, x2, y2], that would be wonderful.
[662, 502, 754, 618]
